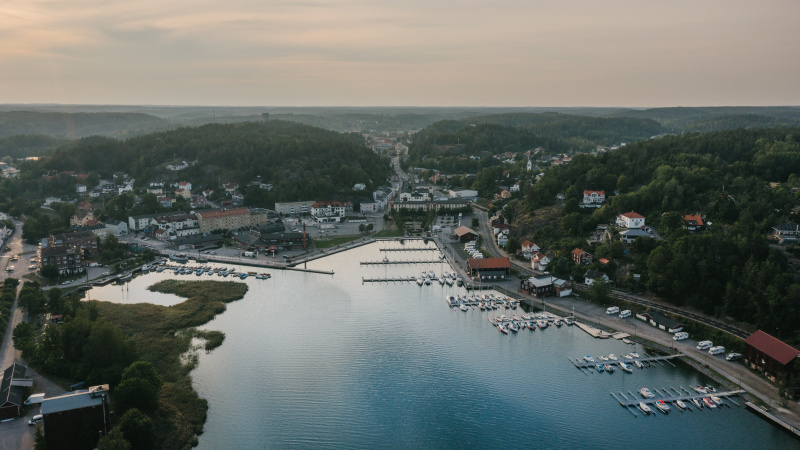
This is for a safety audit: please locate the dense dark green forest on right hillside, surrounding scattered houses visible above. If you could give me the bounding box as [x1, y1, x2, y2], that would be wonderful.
[506, 128, 800, 342]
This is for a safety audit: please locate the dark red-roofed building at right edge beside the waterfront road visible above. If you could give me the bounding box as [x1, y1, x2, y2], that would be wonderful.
[744, 330, 800, 382]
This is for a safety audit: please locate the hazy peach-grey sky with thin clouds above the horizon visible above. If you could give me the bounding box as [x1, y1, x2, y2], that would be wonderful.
[0, 0, 800, 106]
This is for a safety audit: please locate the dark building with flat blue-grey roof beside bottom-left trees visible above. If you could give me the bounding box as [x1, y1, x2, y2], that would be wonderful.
[41, 384, 111, 449]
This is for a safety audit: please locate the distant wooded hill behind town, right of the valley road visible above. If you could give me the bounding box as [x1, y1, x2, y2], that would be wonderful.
[408, 113, 663, 171]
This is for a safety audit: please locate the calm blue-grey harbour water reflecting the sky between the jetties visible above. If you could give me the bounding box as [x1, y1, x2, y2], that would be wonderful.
[89, 242, 797, 449]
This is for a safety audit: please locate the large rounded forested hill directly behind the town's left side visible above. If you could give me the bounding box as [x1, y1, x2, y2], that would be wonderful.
[40, 121, 389, 200]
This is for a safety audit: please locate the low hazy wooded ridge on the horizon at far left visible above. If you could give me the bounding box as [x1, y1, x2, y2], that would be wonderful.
[0, 111, 168, 139]
